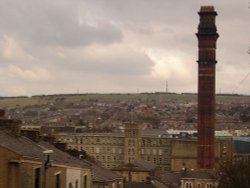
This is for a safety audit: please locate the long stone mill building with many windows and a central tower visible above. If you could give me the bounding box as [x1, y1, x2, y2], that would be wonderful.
[55, 123, 232, 172]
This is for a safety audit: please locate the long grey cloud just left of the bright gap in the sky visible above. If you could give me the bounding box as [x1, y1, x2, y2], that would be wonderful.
[48, 46, 154, 77]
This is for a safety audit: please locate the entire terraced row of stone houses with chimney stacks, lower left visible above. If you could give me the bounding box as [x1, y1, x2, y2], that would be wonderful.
[0, 111, 124, 188]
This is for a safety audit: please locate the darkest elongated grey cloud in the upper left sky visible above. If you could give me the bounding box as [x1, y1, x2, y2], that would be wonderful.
[26, 23, 122, 47]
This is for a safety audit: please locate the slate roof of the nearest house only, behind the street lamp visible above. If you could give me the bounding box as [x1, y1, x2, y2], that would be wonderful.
[0, 131, 89, 168]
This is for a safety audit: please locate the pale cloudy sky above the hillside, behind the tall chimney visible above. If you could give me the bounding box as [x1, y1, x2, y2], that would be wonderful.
[0, 0, 250, 96]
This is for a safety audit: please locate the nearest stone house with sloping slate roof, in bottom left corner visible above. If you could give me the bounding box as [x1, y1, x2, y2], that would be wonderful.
[0, 131, 91, 188]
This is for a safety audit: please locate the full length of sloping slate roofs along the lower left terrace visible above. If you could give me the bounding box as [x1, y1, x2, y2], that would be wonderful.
[0, 131, 123, 183]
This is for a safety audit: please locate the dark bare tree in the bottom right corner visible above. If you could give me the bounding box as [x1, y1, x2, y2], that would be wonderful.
[218, 160, 250, 188]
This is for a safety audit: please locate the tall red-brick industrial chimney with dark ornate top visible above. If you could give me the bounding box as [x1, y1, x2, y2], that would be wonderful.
[196, 6, 219, 169]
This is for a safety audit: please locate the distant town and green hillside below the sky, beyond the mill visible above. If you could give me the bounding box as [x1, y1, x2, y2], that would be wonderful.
[0, 93, 250, 136]
